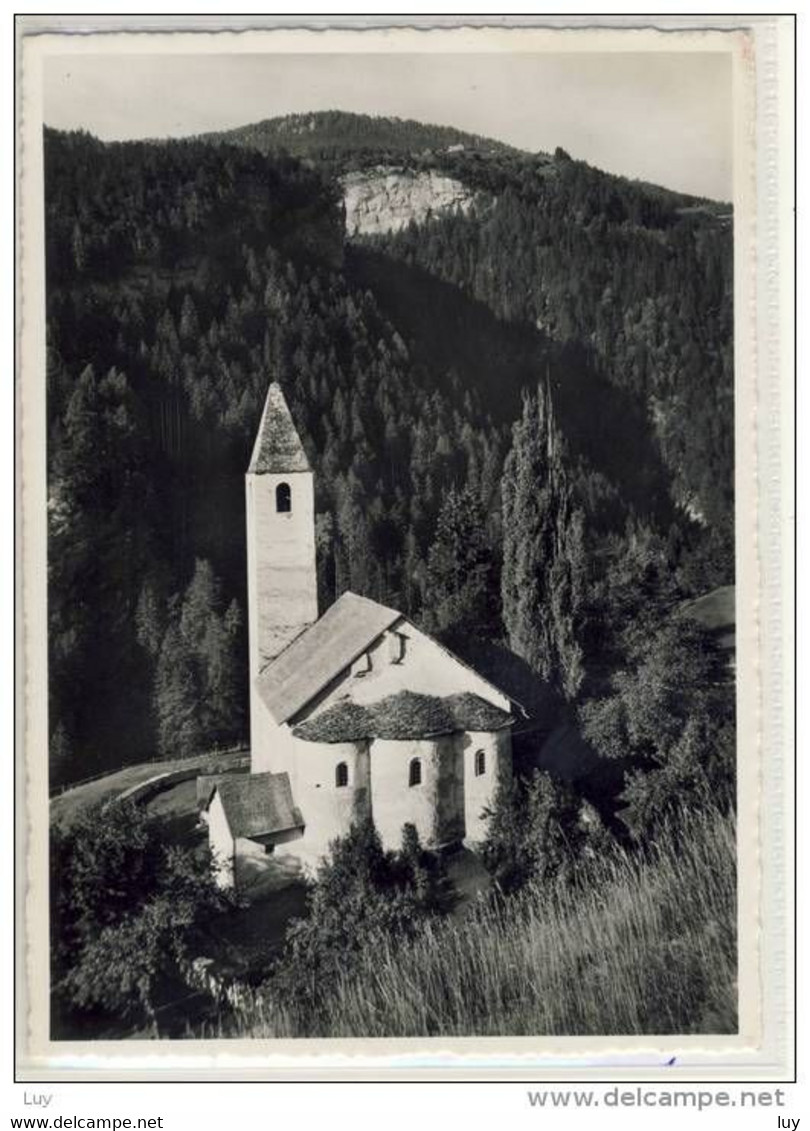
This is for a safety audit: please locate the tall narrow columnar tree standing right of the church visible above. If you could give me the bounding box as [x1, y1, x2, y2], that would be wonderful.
[501, 386, 585, 698]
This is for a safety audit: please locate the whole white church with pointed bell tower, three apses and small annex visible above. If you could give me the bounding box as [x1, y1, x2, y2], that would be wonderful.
[200, 383, 512, 886]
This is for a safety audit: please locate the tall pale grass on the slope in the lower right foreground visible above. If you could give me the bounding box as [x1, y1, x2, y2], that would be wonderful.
[226, 814, 736, 1037]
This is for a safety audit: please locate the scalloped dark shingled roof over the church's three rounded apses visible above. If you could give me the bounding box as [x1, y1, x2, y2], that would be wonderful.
[293, 691, 512, 742]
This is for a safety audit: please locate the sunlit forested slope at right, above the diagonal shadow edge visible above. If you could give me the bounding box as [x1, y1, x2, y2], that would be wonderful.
[369, 158, 733, 533]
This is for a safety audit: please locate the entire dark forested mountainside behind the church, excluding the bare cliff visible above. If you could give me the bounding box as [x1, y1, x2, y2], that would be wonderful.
[45, 114, 733, 796]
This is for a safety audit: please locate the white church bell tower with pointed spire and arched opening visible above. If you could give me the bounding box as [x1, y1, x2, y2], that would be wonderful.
[245, 381, 318, 750]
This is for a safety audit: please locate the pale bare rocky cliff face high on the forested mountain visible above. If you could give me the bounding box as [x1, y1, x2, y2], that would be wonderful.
[341, 166, 473, 236]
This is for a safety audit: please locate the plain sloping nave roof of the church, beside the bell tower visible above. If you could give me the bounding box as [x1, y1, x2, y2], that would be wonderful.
[258, 593, 402, 723]
